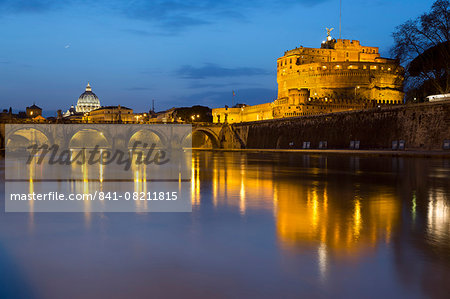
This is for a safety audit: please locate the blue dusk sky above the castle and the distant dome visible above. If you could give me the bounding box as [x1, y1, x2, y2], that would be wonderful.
[0, 0, 433, 116]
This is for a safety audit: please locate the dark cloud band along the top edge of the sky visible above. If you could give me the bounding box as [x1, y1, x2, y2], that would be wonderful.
[0, 0, 329, 34]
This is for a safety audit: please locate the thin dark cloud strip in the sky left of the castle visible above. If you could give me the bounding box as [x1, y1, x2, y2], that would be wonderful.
[176, 63, 270, 79]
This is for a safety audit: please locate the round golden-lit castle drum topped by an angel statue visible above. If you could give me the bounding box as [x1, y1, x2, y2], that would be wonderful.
[277, 28, 403, 104]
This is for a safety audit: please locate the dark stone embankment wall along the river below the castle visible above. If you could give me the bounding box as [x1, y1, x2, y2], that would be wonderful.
[232, 102, 450, 150]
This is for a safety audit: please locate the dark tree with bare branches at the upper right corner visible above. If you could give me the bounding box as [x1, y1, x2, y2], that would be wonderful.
[391, 0, 450, 100]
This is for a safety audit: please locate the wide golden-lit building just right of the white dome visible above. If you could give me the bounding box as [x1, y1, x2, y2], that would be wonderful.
[83, 105, 137, 123]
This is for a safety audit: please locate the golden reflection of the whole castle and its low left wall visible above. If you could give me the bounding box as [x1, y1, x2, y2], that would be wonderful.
[192, 155, 401, 273]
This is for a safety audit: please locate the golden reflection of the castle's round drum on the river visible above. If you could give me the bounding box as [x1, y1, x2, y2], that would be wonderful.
[276, 186, 400, 256]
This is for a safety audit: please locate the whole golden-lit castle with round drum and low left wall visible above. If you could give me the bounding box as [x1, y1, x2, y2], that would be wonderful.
[212, 29, 404, 123]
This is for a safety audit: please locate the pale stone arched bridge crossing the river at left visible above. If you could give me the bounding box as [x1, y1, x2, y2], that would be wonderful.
[0, 123, 236, 148]
